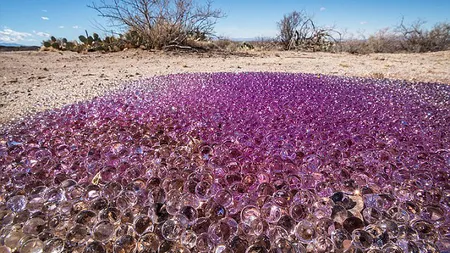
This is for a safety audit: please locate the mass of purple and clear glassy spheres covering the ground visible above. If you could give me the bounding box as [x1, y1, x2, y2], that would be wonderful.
[0, 73, 450, 253]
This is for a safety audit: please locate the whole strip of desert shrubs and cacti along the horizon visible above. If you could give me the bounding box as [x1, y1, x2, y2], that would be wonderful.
[39, 0, 450, 54]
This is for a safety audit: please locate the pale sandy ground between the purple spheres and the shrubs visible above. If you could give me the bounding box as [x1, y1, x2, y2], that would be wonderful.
[0, 50, 450, 125]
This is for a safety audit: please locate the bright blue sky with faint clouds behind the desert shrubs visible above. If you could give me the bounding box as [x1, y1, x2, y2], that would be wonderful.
[0, 0, 450, 45]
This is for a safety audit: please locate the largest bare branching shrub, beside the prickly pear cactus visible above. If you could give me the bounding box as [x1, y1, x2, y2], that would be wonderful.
[88, 0, 224, 48]
